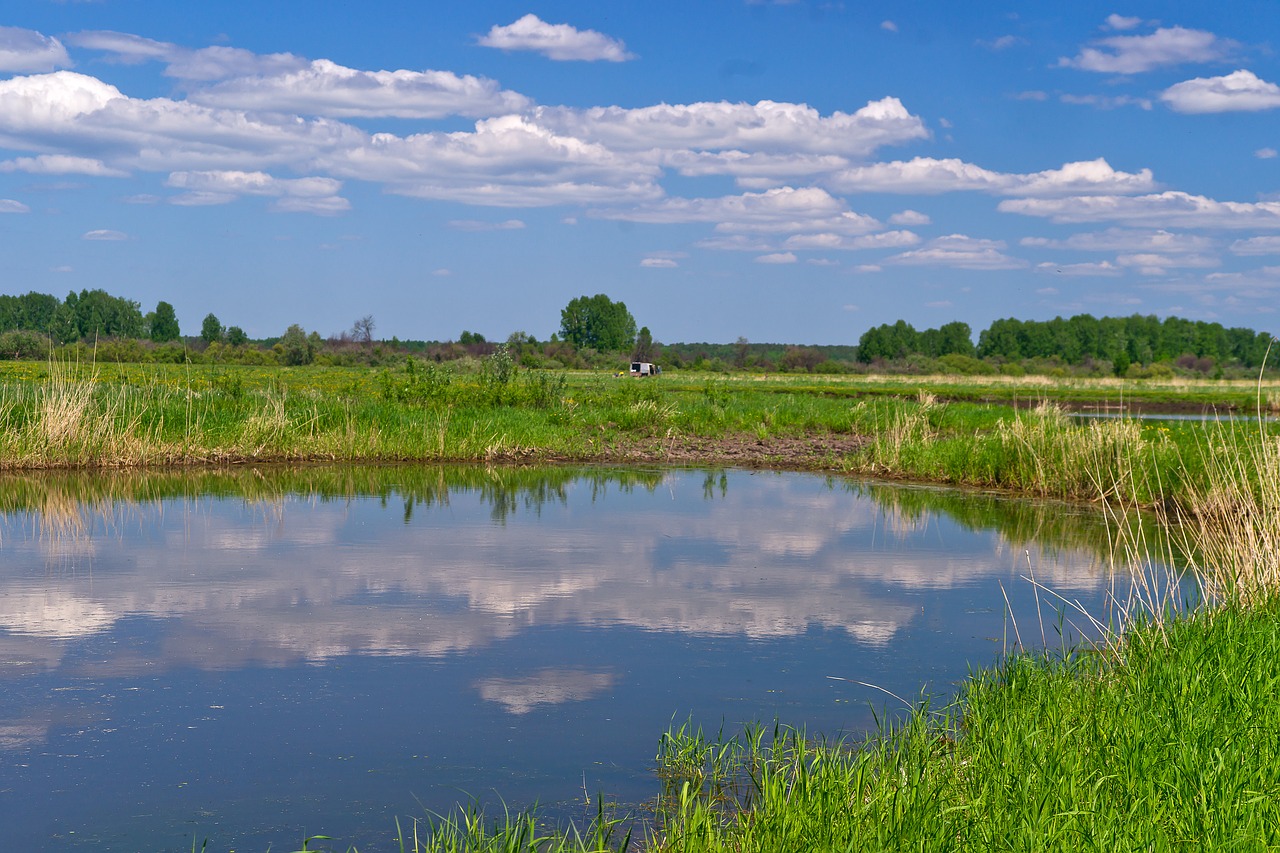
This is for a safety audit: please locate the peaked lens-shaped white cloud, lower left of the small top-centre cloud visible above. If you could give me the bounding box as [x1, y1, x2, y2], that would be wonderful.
[191, 59, 530, 119]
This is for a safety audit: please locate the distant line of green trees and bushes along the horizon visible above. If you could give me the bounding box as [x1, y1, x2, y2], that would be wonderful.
[0, 289, 1272, 378]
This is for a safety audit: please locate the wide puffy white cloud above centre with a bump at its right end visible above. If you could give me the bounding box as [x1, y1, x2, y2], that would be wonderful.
[532, 97, 928, 159]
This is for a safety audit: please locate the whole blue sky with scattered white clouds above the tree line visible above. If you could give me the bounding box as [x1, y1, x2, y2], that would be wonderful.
[0, 0, 1280, 343]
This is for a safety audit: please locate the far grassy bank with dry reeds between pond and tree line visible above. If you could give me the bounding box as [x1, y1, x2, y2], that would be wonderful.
[0, 362, 1274, 506]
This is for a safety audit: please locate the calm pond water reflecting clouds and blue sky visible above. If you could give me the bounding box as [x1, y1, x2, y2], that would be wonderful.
[0, 467, 1131, 852]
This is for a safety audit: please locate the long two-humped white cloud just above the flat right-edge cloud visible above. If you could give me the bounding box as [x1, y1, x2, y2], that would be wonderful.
[829, 158, 1155, 196]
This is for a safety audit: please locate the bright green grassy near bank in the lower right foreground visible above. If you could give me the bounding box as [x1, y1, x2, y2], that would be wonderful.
[402, 603, 1280, 853]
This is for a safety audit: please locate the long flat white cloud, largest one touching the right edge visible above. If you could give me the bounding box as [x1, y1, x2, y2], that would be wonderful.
[997, 192, 1280, 229]
